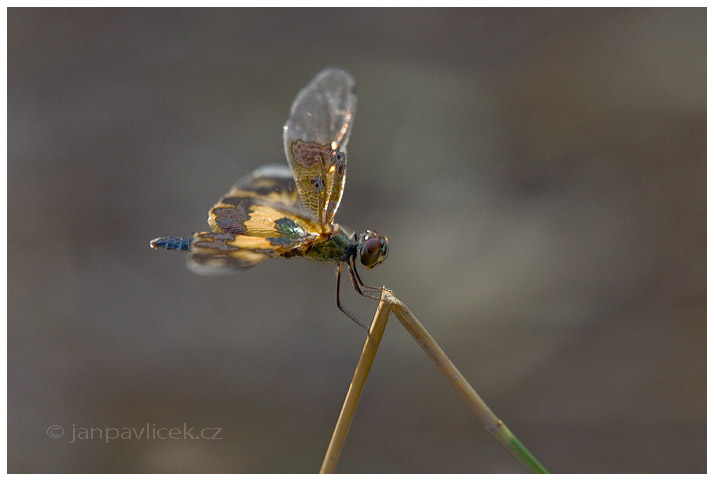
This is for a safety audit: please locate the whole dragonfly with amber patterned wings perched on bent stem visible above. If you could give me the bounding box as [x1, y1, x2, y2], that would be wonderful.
[150, 67, 389, 332]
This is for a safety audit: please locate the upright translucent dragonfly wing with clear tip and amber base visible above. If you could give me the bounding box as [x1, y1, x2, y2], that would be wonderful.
[283, 67, 357, 223]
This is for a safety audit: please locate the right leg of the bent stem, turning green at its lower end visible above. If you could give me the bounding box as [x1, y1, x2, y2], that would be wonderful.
[382, 291, 548, 473]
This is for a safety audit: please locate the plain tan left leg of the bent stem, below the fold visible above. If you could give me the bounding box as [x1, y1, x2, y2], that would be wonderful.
[320, 290, 391, 474]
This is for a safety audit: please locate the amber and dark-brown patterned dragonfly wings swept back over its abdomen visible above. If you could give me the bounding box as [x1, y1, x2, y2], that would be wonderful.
[188, 166, 326, 275]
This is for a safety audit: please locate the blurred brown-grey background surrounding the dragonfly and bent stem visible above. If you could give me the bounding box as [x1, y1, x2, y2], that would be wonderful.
[8, 9, 706, 473]
